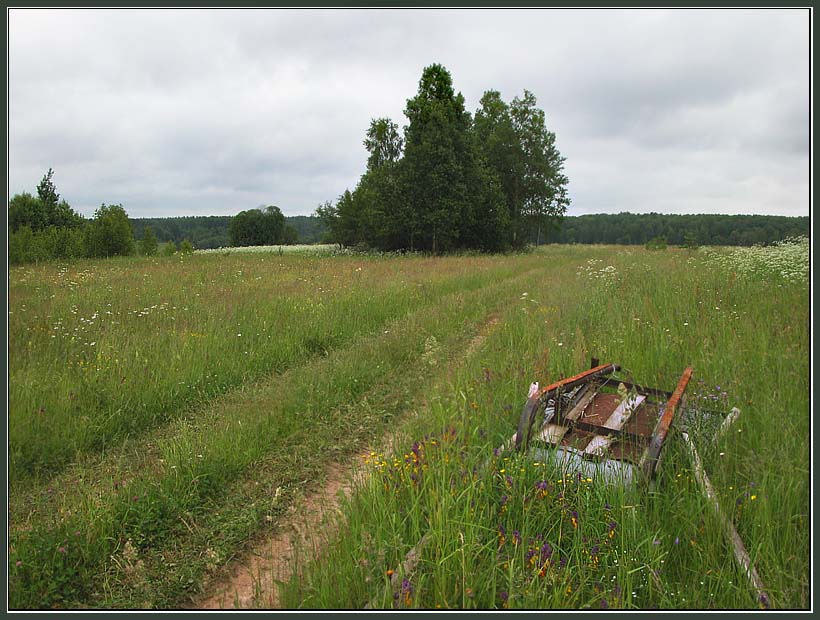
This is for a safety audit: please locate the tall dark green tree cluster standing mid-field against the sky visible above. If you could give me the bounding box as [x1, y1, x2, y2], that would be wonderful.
[316, 64, 569, 253]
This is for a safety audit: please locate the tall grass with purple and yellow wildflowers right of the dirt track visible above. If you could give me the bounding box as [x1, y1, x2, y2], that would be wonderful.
[284, 243, 809, 609]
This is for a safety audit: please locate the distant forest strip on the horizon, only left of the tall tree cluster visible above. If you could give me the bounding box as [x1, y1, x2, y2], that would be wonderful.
[131, 215, 324, 250]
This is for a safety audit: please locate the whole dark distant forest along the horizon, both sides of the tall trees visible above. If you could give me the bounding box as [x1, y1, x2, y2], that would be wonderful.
[131, 213, 810, 249]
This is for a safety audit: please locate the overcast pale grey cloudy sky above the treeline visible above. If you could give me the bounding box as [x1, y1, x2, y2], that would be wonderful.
[7, 9, 811, 217]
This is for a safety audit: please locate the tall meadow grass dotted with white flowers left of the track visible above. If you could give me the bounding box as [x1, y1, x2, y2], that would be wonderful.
[9, 249, 524, 480]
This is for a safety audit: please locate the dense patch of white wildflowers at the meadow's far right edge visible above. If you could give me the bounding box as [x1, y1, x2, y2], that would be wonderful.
[700, 237, 811, 283]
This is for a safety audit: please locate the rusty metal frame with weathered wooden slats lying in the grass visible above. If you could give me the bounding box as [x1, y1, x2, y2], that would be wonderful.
[511, 360, 692, 483]
